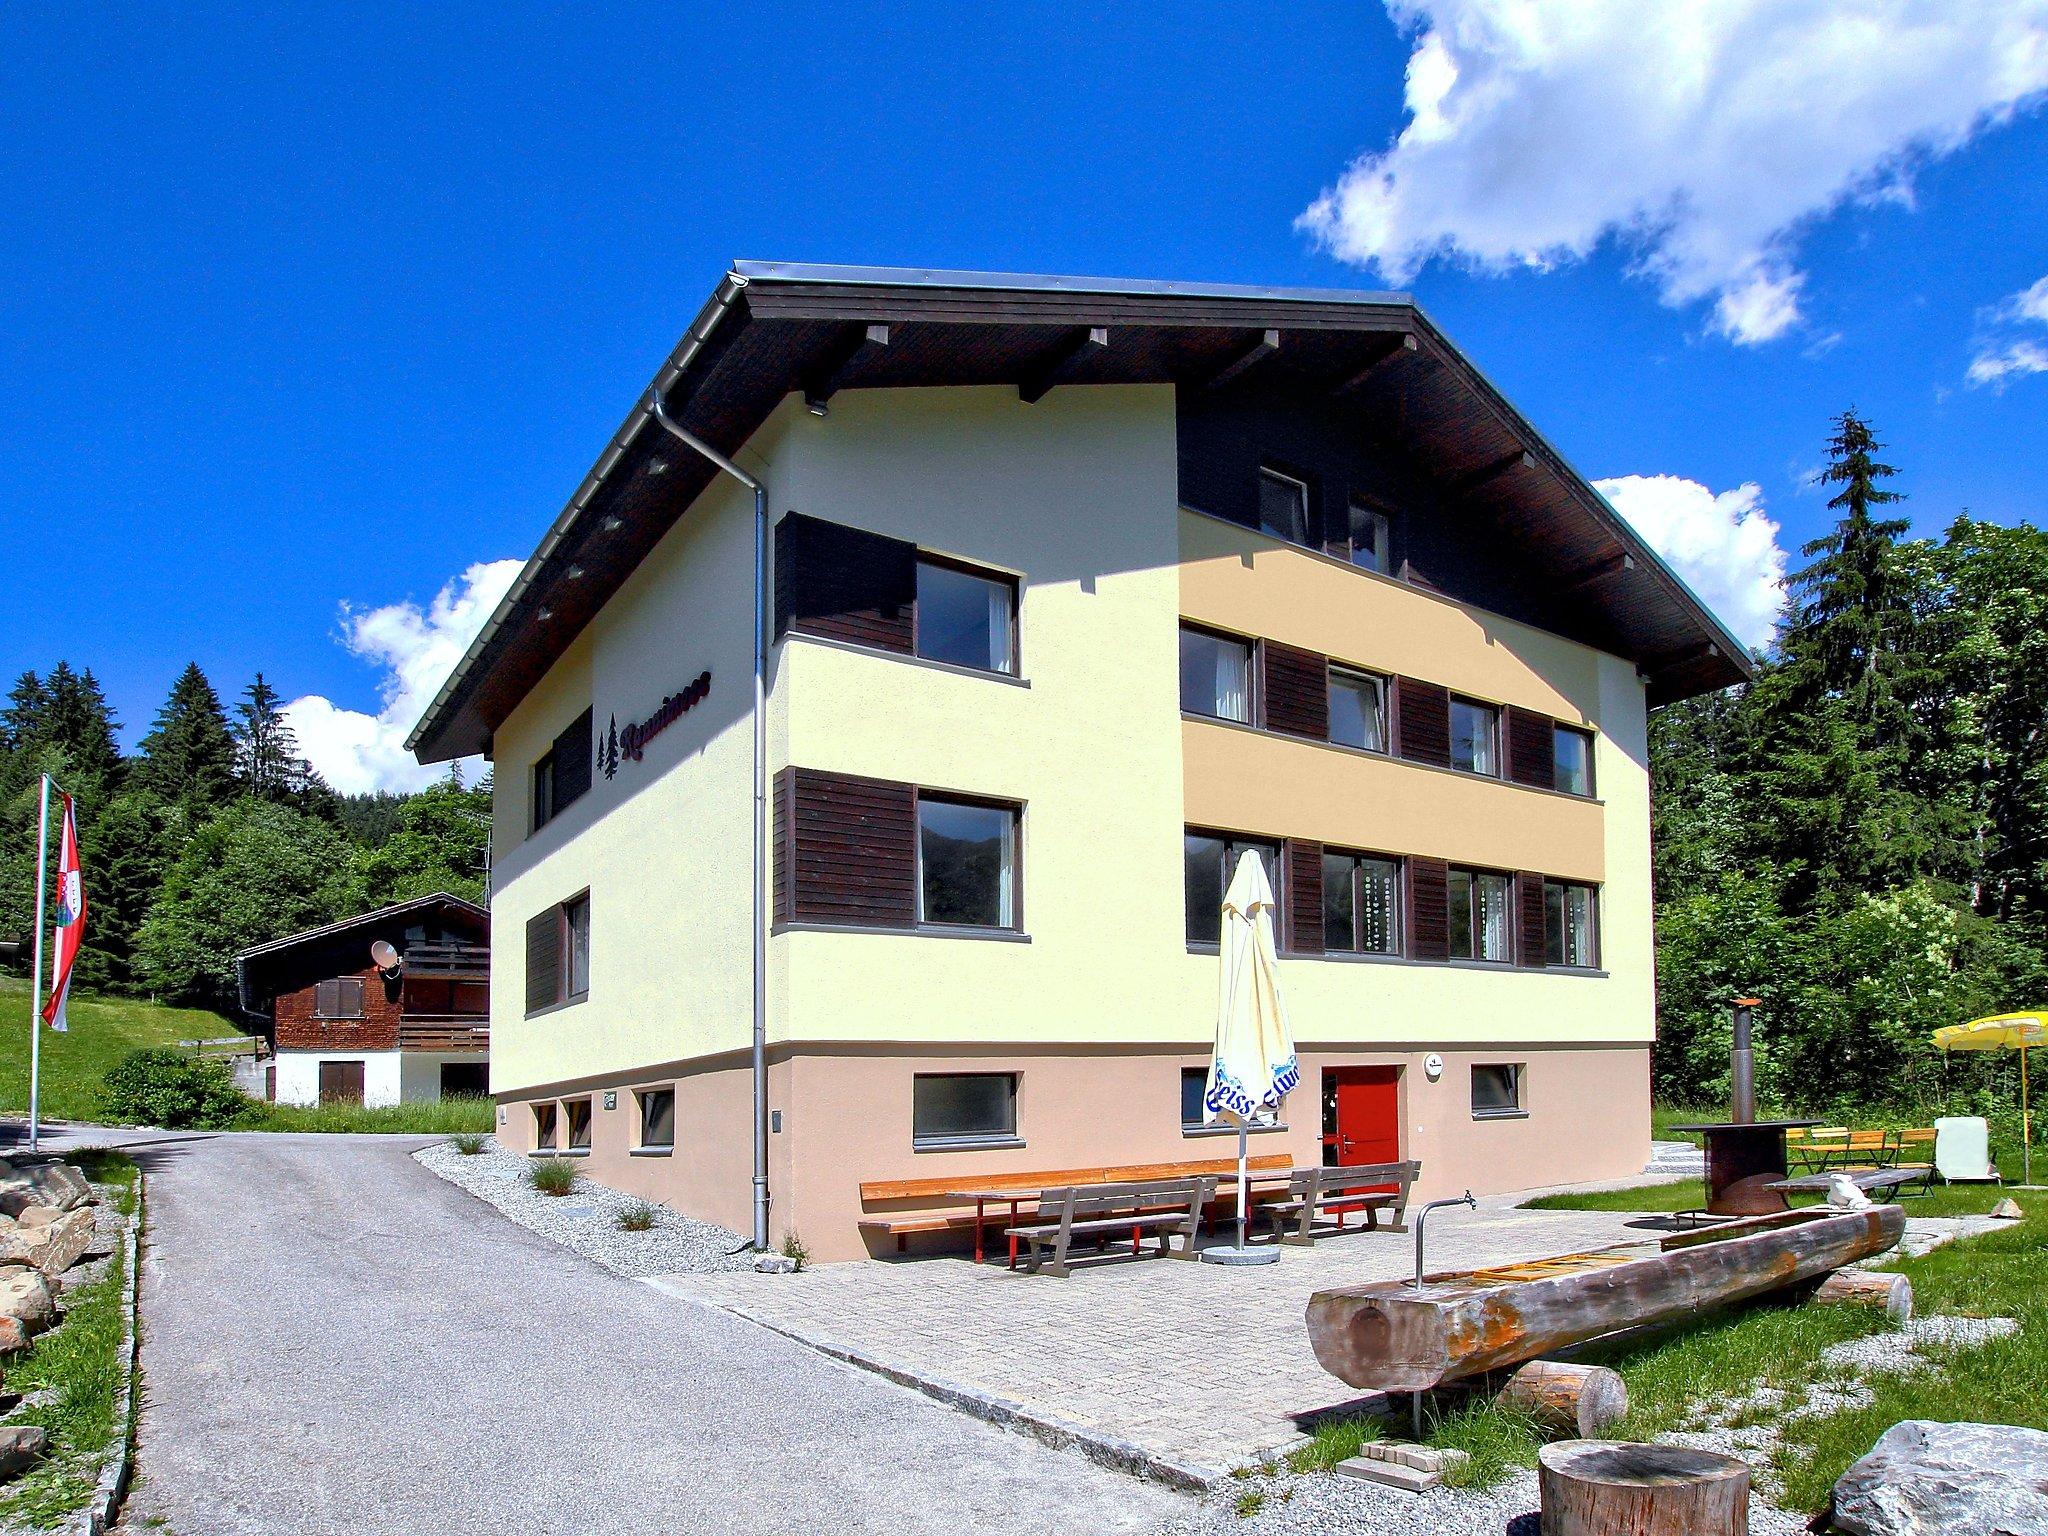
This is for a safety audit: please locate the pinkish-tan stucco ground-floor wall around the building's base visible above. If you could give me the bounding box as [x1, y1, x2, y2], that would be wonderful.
[500, 1040, 1651, 1260]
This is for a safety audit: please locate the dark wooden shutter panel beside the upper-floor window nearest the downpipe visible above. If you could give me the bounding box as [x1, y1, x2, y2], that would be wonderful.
[774, 512, 918, 651]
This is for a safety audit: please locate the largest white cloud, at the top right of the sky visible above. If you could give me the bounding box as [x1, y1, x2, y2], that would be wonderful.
[1300, 0, 2048, 344]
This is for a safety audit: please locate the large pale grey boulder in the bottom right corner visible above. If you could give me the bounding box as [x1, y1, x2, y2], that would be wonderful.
[1833, 1419, 2048, 1536]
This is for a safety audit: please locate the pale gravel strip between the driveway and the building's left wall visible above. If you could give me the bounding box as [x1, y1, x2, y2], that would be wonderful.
[414, 1141, 754, 1278]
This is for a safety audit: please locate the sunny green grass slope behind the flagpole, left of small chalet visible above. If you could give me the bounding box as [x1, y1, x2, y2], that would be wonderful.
[0, 977, 246, 1120]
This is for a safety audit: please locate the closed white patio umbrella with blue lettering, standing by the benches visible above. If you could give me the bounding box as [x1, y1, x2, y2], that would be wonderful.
[1202, 850, 1300, 1255]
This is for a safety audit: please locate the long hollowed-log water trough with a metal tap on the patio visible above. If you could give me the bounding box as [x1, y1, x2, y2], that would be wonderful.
[1309, 1206, 1907, 1393]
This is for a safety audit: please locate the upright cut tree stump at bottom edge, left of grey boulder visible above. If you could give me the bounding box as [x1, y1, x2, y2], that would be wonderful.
[1536, 1440, 1749, 1536]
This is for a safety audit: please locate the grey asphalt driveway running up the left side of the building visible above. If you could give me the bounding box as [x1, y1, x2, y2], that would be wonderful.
[16, 1133, 1186, 1536]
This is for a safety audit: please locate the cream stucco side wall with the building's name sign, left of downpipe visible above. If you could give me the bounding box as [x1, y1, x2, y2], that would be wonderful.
[492, 450, 772, 1096]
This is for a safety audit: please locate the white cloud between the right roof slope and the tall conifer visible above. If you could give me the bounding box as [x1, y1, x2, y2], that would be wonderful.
[1593, 475, 1786, 649]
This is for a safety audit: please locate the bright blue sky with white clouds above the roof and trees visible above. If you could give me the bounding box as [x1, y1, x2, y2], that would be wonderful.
[0, 12, 2048, 786]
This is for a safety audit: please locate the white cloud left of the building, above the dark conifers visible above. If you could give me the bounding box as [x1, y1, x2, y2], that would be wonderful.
[285, 559, 520, 795]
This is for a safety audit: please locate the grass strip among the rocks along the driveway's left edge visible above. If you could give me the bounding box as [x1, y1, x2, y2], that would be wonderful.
[0, 1151, 137, 1530]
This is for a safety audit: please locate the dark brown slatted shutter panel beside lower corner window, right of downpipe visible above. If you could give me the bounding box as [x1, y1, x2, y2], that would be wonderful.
[786, 768, 918, 928]
